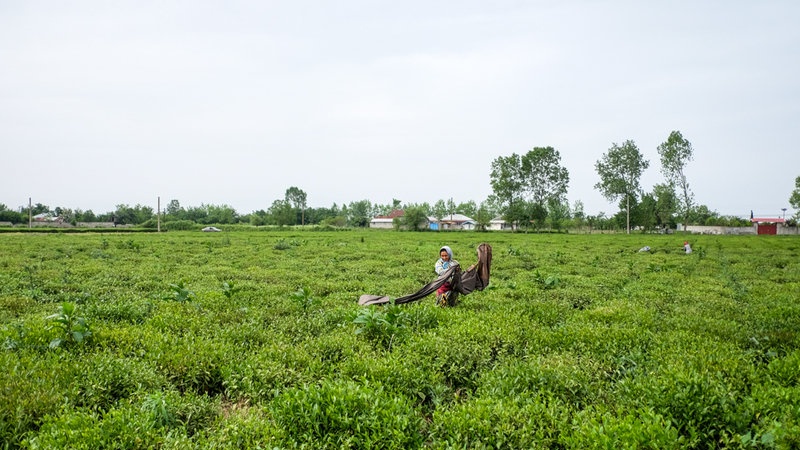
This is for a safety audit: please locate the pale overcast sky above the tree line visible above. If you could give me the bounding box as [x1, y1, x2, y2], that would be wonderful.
[0, 0, 800, 217]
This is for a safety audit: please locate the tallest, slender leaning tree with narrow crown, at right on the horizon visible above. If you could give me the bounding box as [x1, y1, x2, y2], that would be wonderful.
[658, 131, 694, 230]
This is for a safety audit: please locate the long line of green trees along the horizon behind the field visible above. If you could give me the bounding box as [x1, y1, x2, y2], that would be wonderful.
[0, 131, 800, 233]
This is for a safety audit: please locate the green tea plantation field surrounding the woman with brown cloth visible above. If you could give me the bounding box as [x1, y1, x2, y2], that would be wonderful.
[0, 230, 800, 449]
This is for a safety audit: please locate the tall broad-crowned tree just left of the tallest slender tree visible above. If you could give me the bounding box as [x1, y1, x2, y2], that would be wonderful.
[594, 139, 650, 234]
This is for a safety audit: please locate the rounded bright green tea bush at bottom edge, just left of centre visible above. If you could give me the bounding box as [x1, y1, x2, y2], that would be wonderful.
[270, 380, 423, 449]
